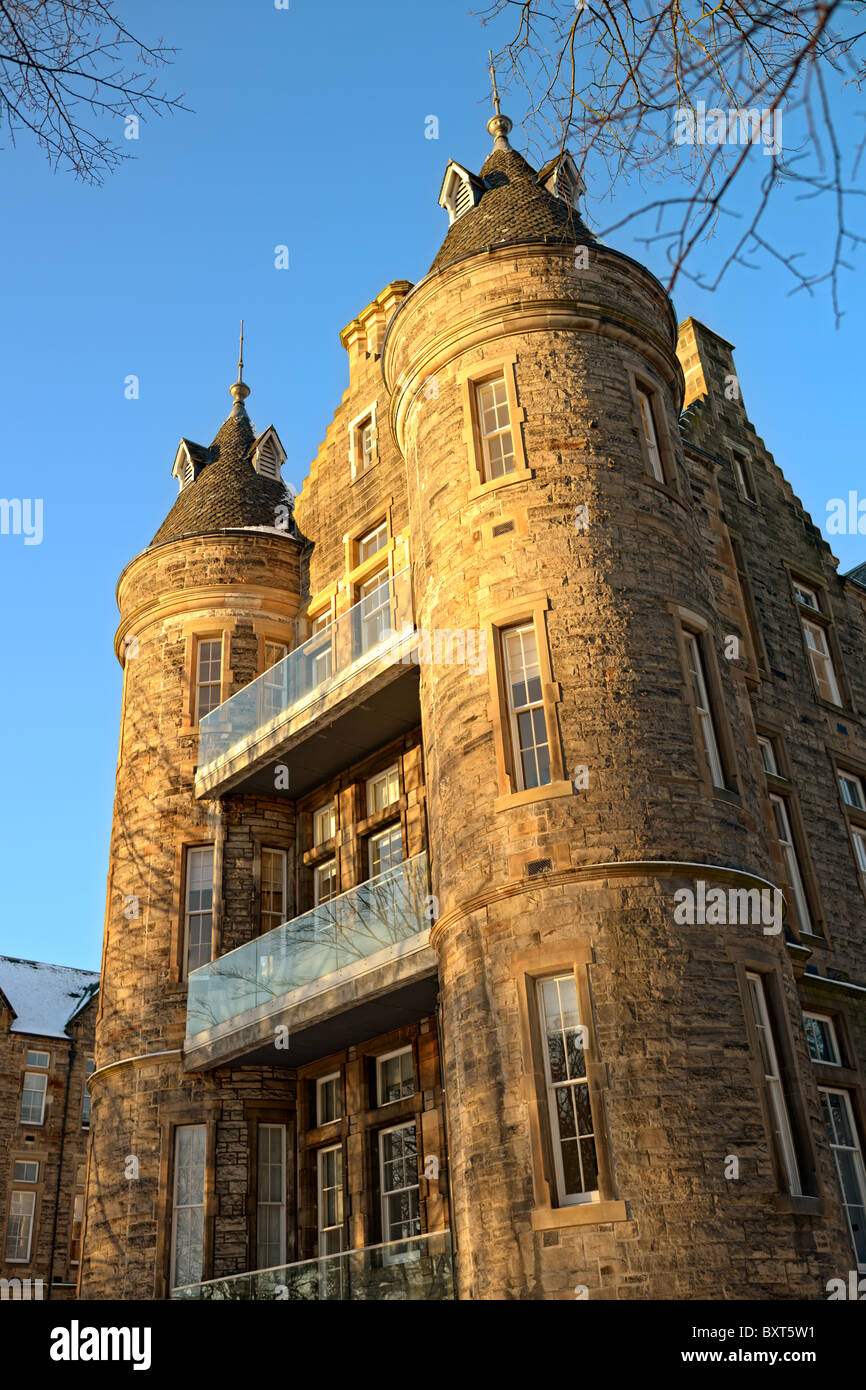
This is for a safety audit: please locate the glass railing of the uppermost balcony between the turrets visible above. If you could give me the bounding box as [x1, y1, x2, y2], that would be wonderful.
[197, 567, 414, 777]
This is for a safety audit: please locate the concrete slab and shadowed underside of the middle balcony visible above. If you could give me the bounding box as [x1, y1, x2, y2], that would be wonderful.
[183, 931, 438, 1072]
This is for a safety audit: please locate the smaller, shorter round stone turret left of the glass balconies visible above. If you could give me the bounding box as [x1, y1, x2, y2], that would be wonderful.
[81, 402, 300, 1300]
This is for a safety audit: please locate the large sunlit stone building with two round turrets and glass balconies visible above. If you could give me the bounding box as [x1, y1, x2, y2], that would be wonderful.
[81, 100, 866, 1300]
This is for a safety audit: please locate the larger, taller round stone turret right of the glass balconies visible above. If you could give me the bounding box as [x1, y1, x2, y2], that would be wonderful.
[384, 135, 828, 1298]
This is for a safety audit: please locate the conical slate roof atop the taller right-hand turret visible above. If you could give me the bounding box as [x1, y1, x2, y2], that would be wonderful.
[430, 147, 594, 271]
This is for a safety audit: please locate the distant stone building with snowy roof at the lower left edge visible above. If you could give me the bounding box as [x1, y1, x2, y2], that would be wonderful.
[0, 956, 99, 1298]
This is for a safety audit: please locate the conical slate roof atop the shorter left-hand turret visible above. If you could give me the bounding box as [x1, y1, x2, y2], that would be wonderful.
[150, 400, 292, 545]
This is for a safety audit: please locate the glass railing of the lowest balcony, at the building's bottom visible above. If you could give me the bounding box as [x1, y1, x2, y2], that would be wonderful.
[171, 1230, 455, 1302]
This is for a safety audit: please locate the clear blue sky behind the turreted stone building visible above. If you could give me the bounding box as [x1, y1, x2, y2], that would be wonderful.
[0, 0, 866, 969]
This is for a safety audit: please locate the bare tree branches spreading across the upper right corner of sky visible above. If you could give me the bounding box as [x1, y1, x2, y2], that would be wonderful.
[480, 0, 866, 321]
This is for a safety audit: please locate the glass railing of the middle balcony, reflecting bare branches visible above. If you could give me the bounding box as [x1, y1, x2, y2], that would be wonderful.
[186, 853, 430, 1047]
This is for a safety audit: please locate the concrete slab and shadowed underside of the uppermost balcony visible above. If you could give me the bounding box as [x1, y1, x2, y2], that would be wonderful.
[196, 646, 421, 801]
